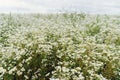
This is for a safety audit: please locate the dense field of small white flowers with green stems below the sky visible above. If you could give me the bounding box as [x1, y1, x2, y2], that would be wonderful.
[0, 13, 120, 80]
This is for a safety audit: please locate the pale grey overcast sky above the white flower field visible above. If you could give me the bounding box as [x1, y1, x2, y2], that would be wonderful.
[0, 0, 120, 14]
